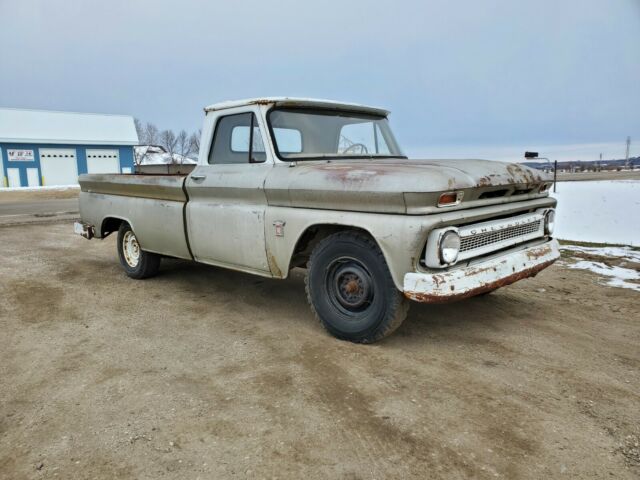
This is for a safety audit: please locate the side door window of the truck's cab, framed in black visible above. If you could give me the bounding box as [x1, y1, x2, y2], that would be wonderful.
[209, 113, 267, 164]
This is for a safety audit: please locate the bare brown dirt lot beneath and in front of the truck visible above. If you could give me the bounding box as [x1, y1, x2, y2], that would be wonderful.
[0, 223, 640, 480]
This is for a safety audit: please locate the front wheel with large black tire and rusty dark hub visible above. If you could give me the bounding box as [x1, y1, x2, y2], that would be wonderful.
[305, 231, 409, 343]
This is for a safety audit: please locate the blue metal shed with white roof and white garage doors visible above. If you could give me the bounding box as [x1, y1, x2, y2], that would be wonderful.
[0, 108, 138, 188]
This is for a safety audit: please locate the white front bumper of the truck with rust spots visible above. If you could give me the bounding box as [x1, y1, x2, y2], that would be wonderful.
[404, 240, 560, 303]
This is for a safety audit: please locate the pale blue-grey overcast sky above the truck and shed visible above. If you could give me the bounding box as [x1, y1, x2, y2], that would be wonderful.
[0, 0, 640, 159]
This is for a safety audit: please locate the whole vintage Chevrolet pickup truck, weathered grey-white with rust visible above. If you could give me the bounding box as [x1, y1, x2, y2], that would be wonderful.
[74, 98, 559, 343]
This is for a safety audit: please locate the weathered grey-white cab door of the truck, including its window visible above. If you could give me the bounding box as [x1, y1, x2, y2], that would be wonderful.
[186, 110, 273, 276]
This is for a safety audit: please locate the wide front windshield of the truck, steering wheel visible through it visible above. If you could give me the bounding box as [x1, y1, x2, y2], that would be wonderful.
[269, 109, 406, 160]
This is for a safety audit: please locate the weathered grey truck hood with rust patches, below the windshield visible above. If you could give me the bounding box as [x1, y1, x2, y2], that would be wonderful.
[265, 159, 549, 213]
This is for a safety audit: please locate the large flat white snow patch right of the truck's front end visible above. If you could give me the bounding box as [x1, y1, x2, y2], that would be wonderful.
[551, 180, 640, 246]
